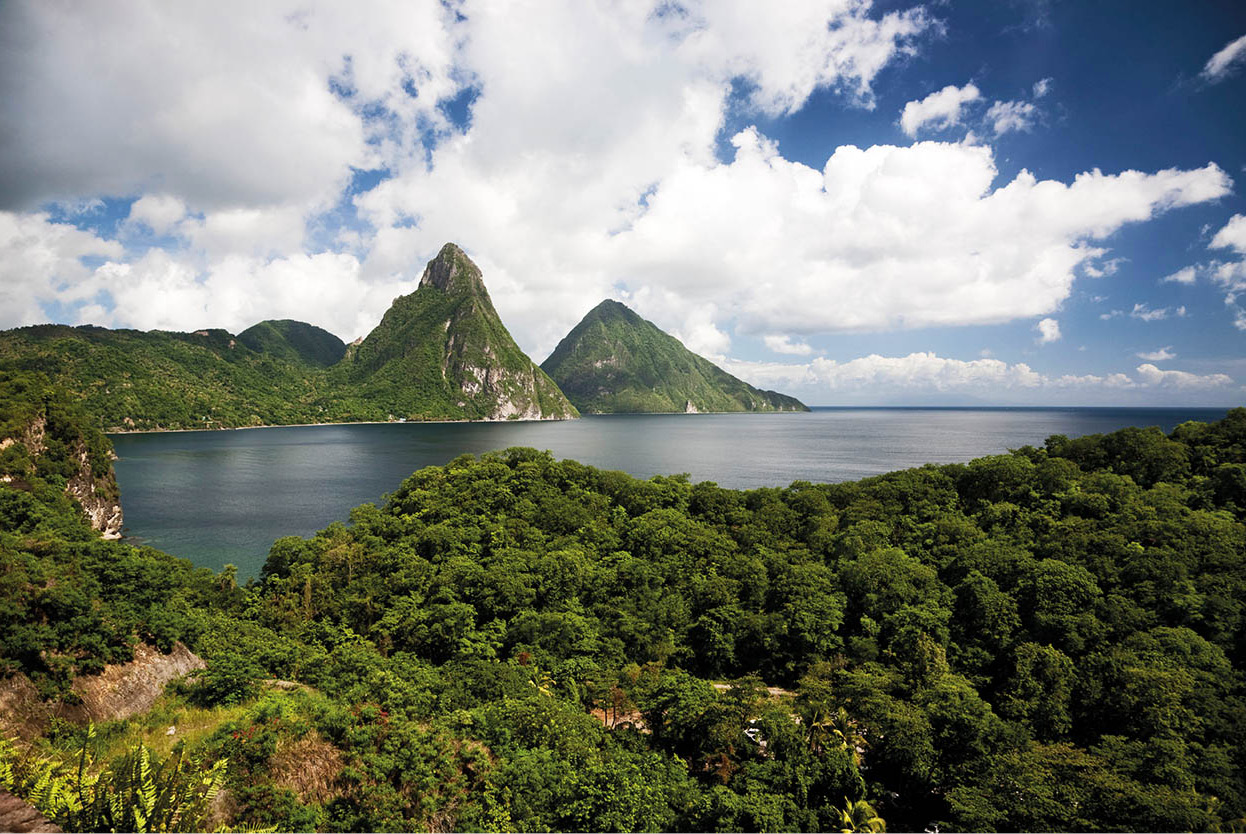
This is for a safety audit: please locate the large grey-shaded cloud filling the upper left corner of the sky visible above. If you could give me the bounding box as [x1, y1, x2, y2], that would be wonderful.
[0, 0, 441, 211]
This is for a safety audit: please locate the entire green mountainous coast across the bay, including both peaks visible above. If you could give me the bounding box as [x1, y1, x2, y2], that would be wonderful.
[0, 243, 807, 431]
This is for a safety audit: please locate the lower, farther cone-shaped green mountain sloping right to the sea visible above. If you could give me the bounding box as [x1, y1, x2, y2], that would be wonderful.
[541, 300, 809, 414]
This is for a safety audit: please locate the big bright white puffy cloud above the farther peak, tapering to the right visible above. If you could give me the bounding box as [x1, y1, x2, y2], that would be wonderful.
[607, 138, 1229, 346]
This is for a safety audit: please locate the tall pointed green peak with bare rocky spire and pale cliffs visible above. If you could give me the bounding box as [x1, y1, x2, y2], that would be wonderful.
[331, 243, 578, 420]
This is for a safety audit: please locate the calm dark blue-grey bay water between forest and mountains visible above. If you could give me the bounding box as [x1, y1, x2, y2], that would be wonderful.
[112, 408, 1225, 578]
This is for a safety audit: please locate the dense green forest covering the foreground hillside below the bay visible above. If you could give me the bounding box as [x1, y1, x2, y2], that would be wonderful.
[0, 378, 1246, 830]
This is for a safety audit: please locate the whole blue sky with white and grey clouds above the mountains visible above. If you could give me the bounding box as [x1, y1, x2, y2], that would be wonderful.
[0, 0, 1246, 405]
